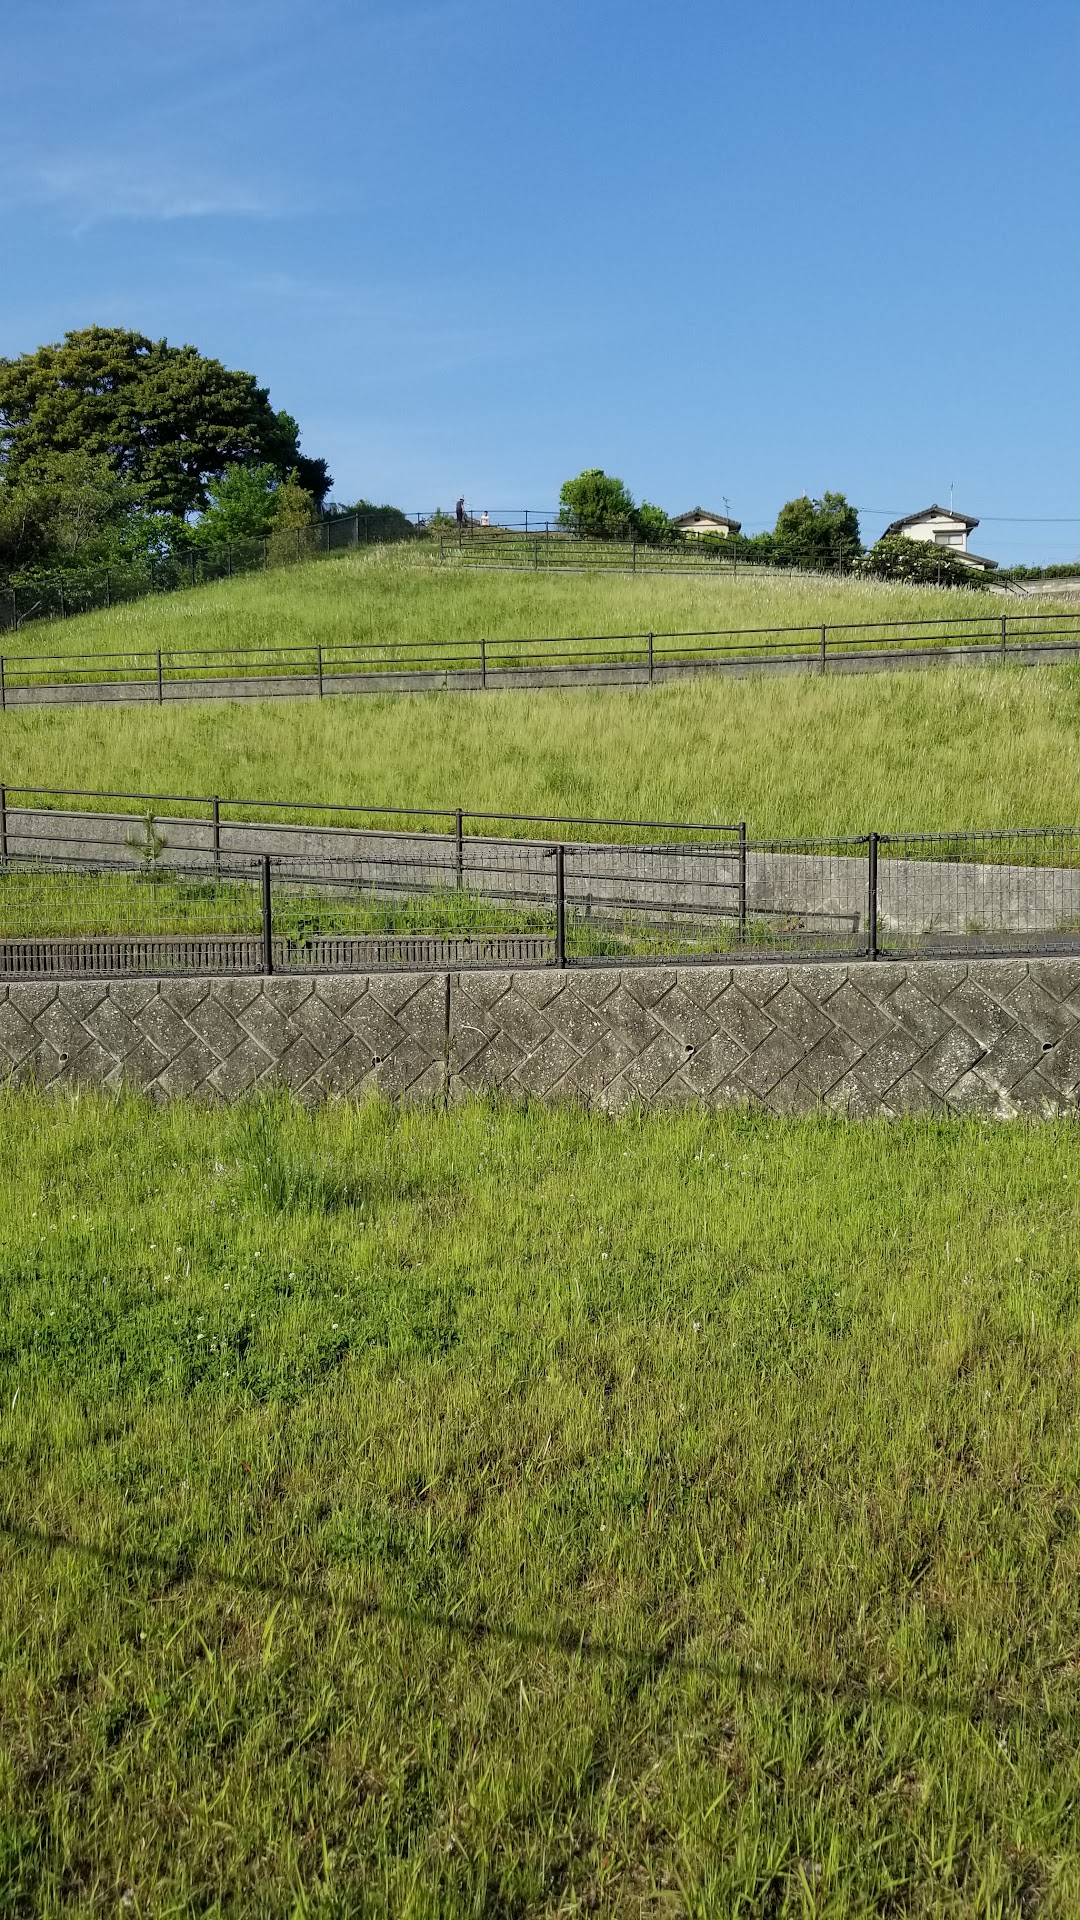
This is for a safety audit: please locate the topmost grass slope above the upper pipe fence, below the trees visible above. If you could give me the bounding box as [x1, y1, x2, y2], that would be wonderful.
[4, 549, 1015, 659]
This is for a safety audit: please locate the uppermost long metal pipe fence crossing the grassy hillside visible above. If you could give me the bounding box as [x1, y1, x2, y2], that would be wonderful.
[0, 609, 1080, 708]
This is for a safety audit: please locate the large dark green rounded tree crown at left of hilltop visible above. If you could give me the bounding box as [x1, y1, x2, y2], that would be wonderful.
[0, 326, 331, 516]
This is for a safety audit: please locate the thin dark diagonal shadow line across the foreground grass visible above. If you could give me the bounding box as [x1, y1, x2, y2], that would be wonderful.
[0, 1517, 1080, 1730]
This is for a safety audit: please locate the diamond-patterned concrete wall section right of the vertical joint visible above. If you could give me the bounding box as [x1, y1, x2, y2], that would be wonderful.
[450, 960, 1080, 1119]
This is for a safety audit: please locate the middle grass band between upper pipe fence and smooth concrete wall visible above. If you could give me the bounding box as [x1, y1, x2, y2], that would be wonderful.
[0, 666, 1080, 835]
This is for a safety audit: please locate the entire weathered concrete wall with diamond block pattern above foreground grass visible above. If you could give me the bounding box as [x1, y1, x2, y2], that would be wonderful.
[0, 958, 1080, 1119]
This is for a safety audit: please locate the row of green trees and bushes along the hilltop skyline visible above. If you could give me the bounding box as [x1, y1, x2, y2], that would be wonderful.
[0, 326, 999, 588]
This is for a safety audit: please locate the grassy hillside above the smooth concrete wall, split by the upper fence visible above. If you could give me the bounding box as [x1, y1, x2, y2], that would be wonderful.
[0, 551, 1080, 833]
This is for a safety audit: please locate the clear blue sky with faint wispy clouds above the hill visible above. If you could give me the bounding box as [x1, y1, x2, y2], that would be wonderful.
[0, 0, 1080, 563]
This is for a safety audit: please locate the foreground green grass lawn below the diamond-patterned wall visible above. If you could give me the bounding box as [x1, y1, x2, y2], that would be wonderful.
[0, 1092, 1080, 1916]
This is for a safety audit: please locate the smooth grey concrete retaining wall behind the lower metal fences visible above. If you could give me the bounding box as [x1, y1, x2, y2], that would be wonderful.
[6, 804, 1080, 952]
